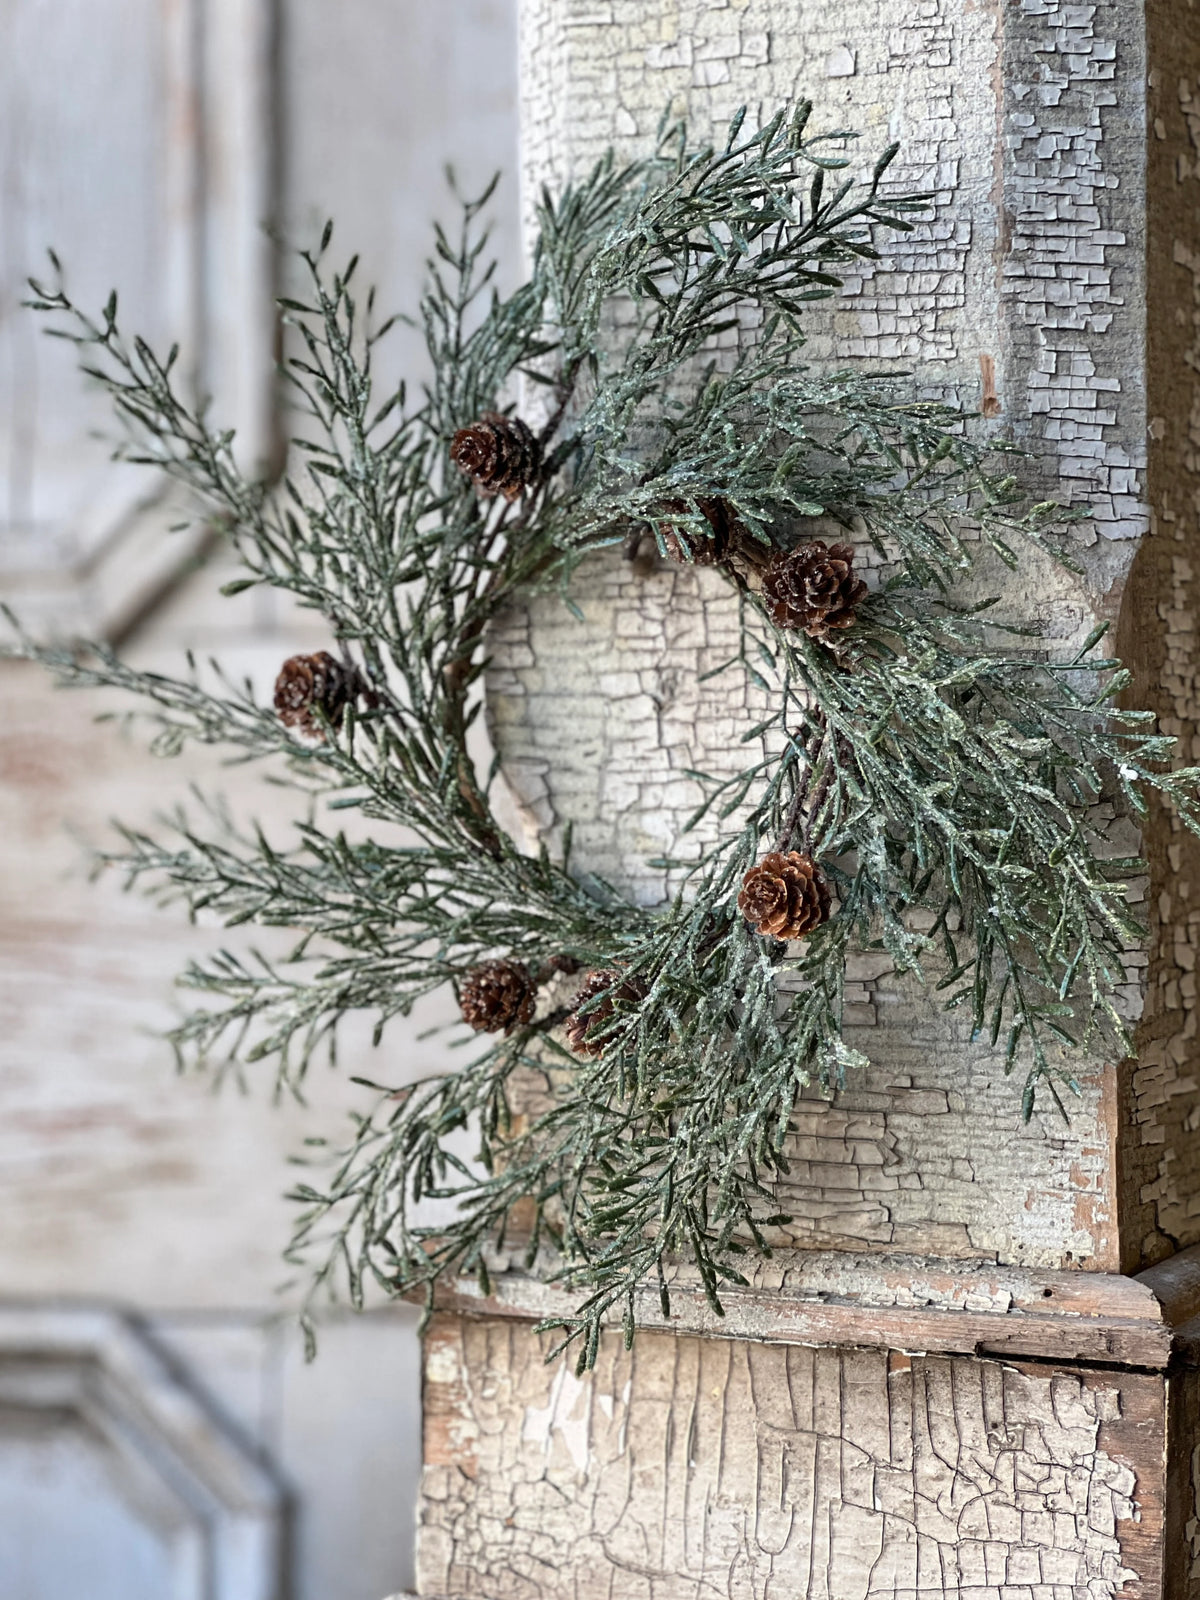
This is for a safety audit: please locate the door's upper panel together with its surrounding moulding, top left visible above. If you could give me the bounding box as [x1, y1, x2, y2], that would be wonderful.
[0, 0, 274, 632]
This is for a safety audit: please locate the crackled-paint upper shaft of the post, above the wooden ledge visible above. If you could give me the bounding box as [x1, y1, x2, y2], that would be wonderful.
[488, 0, 1200, 1269]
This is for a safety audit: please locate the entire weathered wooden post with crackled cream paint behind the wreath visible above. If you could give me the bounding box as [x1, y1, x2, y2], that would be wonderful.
[419, 0, 1200, 1600]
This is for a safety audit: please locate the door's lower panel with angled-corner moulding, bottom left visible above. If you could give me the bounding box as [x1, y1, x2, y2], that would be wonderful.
[0, 1306, 285, 1600]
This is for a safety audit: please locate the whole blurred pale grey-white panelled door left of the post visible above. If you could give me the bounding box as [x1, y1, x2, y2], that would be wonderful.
[0, 0, 518, 1600]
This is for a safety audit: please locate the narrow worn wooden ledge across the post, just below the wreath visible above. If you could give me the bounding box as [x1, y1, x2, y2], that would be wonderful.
[437, 1246, 1200, 1370]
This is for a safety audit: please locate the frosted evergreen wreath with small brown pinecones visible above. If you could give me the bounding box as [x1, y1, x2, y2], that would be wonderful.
[9, 102, 1200, 1366]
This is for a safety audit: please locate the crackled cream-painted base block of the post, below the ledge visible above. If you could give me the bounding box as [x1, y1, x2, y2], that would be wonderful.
[418, 1318, 1165, 1600]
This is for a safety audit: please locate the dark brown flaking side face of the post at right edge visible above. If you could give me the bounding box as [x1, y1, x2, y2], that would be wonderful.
[1117, 0, 1200, 1261]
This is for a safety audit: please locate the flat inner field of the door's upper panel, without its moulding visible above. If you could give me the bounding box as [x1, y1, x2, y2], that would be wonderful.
[0, 0, 183, 570]
